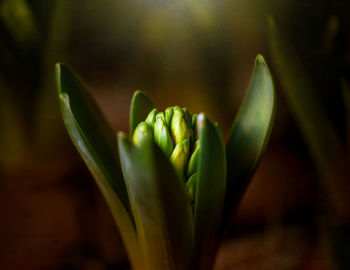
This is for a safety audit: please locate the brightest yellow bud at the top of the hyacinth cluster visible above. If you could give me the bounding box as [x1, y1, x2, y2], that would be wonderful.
[171, 107, 192, 144]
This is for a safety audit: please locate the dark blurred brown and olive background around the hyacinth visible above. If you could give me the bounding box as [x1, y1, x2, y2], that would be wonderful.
[0, 0, 350, 270]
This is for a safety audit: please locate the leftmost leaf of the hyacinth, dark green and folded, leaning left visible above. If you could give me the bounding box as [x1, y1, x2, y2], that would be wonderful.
[56, 64, 139, 267]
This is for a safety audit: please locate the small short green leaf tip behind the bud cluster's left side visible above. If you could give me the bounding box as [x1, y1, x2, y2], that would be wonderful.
[130, 91, 154, 136]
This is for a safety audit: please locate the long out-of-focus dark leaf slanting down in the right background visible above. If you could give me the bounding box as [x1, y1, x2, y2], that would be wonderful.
[268, 18, 350, 220]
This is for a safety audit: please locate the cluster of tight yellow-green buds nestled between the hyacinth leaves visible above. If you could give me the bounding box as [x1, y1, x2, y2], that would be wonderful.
[133, 106, 199, 185]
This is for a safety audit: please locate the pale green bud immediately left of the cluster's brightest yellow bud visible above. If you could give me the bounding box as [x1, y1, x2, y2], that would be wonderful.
[154, 112, 174, 158]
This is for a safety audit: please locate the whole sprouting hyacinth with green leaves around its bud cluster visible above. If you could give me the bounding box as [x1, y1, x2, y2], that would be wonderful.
[56, 55, 275, 270]
